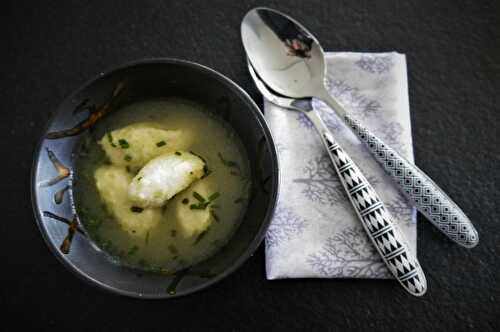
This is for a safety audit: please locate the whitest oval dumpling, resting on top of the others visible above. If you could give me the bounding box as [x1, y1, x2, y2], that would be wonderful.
[128, 151, 205, 208]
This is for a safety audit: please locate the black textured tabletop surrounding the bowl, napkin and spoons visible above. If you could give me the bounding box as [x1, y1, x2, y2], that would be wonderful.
[0, 0, 500, 331]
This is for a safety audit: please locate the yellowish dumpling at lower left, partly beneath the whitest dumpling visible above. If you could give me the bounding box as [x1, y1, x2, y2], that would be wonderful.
[94, 165, 161, 237]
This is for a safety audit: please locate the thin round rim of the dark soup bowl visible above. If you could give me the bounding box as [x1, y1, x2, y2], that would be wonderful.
[30, 57, 280, 300]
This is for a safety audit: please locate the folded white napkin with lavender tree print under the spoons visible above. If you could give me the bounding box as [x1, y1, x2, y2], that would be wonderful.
[264, 52, 416, 279]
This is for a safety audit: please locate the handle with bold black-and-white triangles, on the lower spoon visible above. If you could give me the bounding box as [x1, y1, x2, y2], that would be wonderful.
[305, 110, 427, 296]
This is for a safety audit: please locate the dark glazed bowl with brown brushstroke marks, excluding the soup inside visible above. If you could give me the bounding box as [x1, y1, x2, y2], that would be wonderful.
[32, 59, 279, 298]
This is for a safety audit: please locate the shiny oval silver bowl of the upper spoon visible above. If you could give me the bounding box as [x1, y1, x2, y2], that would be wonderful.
[241, 7, 326, 98]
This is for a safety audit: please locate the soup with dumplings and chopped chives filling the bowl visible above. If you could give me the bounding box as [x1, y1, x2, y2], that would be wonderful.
[73, 99, 251, 273]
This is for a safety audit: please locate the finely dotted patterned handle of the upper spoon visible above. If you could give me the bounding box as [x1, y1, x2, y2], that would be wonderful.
[344, 115, 479, 248]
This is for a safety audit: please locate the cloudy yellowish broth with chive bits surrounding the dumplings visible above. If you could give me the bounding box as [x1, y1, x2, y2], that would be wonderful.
[73, 99, 251, 273]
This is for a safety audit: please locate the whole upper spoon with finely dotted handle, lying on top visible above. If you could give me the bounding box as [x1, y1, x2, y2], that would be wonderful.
[241, 7, 479, 248]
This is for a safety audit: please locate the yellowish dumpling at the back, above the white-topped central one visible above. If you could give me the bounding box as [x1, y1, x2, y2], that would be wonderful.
[99, 122, 192, 170]
